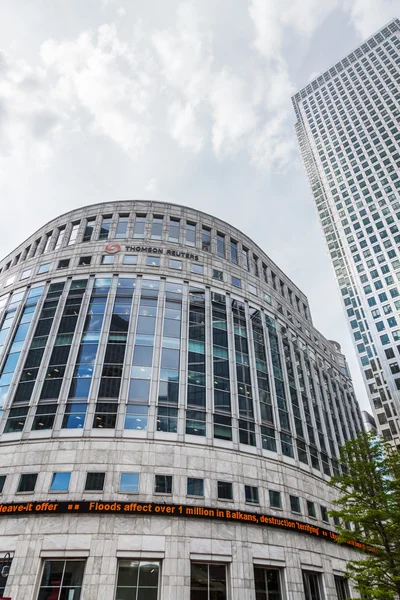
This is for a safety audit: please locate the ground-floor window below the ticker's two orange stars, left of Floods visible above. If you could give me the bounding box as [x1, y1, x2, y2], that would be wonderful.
[37, 560, 85, 600]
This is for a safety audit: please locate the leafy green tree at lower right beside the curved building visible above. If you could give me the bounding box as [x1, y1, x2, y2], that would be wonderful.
[330, 433, 400, 600]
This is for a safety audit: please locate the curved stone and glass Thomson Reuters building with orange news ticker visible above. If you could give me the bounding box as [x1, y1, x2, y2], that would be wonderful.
[0, 201, 362, 600]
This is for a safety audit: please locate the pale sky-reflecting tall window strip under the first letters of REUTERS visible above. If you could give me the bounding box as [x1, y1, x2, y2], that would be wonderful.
[157, 281, 183, 433]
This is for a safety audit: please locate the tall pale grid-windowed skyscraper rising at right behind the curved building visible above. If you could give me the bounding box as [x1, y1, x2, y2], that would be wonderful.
[292, 19, 400, 444]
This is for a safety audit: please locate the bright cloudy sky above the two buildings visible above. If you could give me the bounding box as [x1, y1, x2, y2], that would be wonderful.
[0, 0, 400, 408]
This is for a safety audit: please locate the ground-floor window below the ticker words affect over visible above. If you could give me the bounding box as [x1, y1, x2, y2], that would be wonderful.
[115, 560, 160, 600]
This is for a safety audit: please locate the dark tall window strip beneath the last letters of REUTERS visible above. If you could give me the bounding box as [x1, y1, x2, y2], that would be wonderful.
[186, 287, 206, 436]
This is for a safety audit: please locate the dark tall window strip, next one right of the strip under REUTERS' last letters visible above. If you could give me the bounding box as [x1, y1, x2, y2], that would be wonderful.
[211, 292, 232, 440]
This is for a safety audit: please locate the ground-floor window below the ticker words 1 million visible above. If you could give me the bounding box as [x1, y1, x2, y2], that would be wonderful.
[190, 562, 228, 600]
